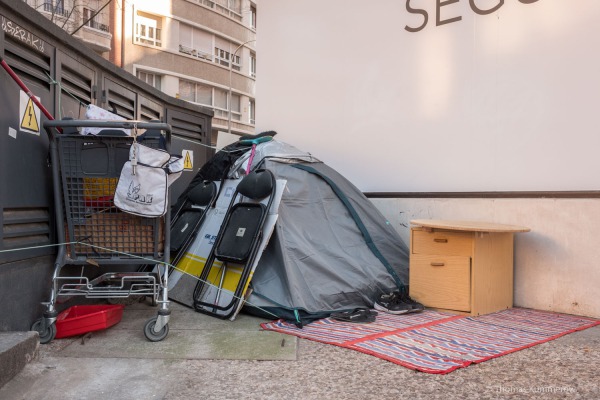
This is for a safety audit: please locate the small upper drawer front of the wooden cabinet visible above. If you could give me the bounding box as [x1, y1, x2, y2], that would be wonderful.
[411, 229, 473, 257]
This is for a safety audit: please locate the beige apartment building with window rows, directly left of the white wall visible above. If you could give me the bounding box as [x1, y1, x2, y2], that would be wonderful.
[108, 0, 257, 144]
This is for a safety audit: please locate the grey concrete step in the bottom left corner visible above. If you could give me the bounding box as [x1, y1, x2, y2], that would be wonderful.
[0, 332, 40, 388]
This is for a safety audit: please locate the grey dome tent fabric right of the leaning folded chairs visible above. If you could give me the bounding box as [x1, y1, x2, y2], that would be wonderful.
[241, 141, 408, 322]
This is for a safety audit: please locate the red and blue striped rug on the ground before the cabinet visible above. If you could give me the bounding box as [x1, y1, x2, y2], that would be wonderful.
[261, 308, 600, 374]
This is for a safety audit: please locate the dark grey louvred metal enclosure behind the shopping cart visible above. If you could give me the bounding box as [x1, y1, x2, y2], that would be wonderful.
[0, 0, 213, 331]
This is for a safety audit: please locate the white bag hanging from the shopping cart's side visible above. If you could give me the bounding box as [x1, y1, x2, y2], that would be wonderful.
[114, 140, 183, 217]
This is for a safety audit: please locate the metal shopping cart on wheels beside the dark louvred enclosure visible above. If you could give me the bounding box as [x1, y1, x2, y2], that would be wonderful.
[31, 120, 171, 343]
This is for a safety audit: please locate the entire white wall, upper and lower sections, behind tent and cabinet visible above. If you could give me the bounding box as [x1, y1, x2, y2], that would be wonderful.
[257, 0, 600, 317]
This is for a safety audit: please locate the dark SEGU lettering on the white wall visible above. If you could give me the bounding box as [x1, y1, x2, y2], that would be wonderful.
[404, 0, 539, 32]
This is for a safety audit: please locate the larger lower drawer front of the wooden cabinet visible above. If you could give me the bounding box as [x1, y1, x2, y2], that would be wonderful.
[409, 255, 471, 312]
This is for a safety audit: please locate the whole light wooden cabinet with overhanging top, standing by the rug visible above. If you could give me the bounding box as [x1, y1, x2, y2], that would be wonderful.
[409, 220, 529, 315]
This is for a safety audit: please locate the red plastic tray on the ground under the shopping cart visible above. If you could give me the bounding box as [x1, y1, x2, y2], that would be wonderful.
[56, 304, 124, 339]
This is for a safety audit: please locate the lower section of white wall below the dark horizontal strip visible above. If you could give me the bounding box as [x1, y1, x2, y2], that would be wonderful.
[372, 199, 600, 317]
